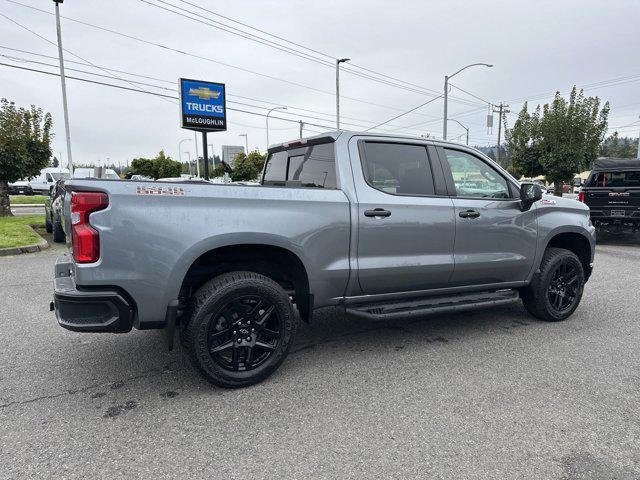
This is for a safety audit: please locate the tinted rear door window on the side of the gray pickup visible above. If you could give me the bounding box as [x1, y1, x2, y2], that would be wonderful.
[362, 142, 435, 195]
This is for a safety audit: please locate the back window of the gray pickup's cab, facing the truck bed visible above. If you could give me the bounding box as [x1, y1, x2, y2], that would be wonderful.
[262, 142, 337, 189]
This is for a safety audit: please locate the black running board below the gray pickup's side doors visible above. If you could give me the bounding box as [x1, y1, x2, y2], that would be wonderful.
[345, 289, 520, 320]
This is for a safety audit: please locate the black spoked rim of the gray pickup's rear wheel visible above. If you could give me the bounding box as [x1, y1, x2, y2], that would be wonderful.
[207, 295, 283, 372]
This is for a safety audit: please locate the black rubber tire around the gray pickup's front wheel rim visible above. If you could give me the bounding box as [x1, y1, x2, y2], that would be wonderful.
[520, 248, 585, 322]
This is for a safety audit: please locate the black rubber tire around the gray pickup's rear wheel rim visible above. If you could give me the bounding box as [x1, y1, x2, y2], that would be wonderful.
[181, 272, 298, 388]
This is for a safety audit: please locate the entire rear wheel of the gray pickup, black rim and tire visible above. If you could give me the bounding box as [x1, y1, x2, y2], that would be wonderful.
[182, 272, 298, 388]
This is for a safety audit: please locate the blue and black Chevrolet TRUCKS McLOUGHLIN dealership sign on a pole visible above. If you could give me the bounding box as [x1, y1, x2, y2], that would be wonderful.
[180, 78, 227, 132]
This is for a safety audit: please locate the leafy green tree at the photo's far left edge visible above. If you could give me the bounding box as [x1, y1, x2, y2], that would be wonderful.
[0, 98, 51, 217]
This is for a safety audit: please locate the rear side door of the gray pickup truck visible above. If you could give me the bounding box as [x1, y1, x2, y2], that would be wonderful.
[353, 142, 455, 295]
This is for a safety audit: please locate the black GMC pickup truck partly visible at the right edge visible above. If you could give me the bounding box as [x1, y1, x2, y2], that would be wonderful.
[578, 158, 640, 233]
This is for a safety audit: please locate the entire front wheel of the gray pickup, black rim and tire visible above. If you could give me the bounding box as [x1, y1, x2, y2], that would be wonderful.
[521, 248, 585, 322]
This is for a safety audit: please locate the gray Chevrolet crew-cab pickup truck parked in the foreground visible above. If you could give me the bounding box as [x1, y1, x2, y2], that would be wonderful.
[52, 132, 595, 387]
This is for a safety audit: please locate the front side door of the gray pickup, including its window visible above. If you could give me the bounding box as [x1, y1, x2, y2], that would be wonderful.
[438, 148, 538, 286]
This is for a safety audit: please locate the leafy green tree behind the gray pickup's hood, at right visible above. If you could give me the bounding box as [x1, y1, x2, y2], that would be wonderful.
[506, 87, 609, 196]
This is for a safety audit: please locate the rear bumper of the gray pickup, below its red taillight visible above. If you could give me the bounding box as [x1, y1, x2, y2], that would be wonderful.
[51, 255, 135, 333]
